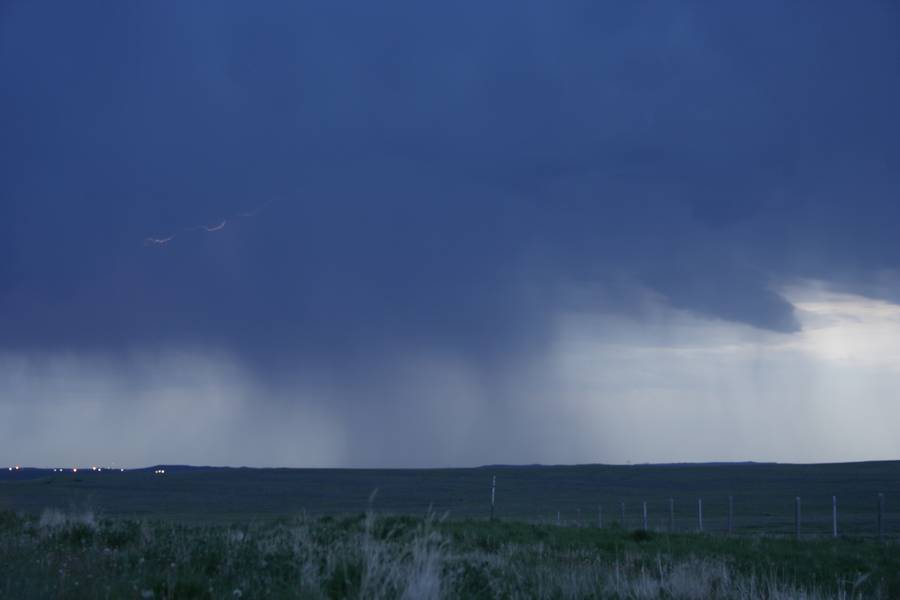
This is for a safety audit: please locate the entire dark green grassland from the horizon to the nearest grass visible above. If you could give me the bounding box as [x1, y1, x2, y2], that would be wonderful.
[0, 462, 900, 599]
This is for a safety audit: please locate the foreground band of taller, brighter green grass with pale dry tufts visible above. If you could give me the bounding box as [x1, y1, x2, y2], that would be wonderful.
[0, 510, 900, 600]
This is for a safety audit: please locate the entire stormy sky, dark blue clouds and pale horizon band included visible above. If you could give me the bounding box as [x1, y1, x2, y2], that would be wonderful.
[0, 0, 900, 467]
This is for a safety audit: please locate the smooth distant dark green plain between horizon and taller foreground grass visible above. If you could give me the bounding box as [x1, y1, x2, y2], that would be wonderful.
[0, 462, 900, 537]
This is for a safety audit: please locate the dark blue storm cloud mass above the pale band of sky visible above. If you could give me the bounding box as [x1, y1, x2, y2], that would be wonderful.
[0, 2, 900, 365]
